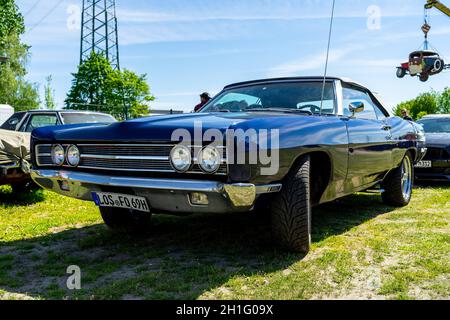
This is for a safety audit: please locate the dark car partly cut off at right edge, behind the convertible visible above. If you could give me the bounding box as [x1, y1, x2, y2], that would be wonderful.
[416, 115, 450, 181]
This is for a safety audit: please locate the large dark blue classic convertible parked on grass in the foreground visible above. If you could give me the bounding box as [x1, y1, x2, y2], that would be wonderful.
[32, 77, 426, 252]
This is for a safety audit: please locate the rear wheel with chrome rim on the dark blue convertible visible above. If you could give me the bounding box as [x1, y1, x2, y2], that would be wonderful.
[382, 152, 414, 207]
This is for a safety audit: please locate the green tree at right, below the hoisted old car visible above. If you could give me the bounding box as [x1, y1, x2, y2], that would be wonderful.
[394, 92, 439, 120]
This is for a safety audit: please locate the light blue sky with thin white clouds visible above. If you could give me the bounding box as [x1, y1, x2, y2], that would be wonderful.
[16, 0, 450, 111]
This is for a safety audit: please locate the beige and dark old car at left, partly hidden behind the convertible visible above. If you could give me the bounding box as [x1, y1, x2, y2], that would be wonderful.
[0, 110, 117, 191]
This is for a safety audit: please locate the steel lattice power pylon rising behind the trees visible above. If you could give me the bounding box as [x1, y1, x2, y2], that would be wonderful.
[80, 0, 120, 69]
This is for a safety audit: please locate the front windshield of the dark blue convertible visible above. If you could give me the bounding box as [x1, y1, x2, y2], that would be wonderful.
[201, 82, 336, 114]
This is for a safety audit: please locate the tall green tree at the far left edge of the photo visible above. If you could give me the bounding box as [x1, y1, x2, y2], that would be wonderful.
[0, 0, 40, 111]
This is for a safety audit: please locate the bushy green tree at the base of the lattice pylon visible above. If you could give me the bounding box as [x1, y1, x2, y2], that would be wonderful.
[65, 52, 154, 119]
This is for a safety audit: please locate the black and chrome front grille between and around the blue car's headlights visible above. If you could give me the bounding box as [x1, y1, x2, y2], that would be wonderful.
[36, 144, 228, 175]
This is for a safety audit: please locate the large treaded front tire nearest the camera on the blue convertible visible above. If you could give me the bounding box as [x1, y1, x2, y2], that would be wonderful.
[271, 156, 311, 254]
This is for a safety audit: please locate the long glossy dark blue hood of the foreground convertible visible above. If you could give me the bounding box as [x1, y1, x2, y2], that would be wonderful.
[33, 112, 319, 143]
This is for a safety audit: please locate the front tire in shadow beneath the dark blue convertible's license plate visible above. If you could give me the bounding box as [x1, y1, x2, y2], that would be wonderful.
[100, 208, 152, 235]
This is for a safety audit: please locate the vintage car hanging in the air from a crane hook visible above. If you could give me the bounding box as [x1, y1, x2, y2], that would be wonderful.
[397, 50, 448, 82]
